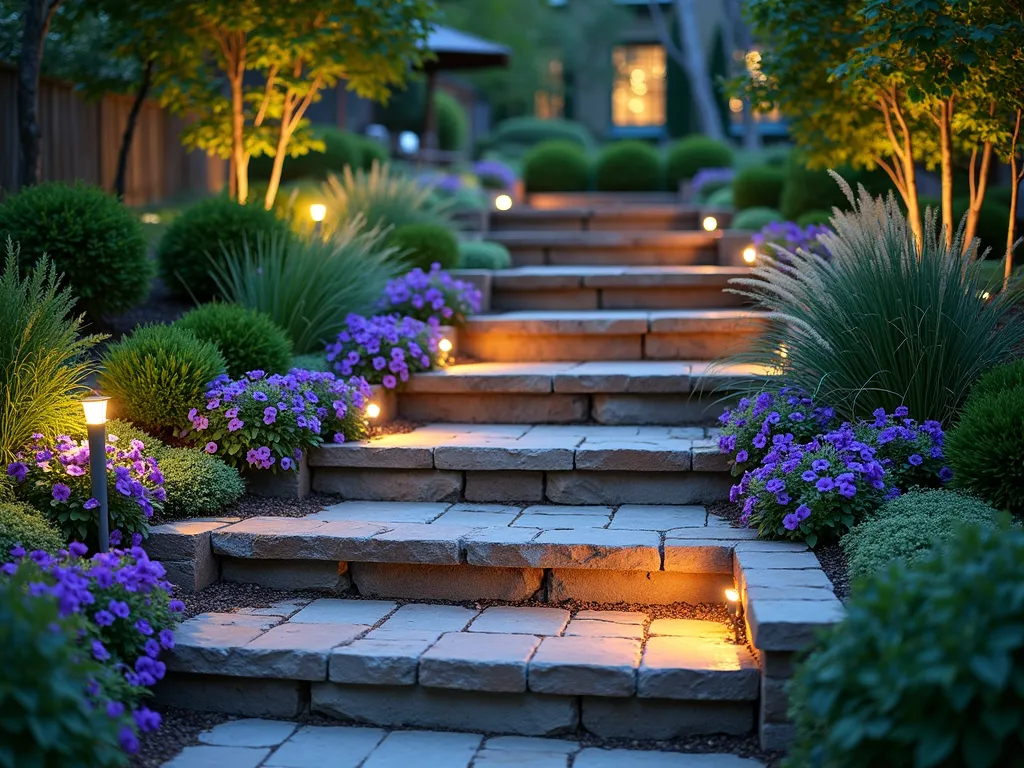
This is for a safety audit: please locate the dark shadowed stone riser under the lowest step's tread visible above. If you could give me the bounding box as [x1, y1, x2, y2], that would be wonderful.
[156, 673, 757, 739]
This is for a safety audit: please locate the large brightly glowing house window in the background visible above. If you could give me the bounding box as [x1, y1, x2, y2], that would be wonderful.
[611, 45, 665, 127]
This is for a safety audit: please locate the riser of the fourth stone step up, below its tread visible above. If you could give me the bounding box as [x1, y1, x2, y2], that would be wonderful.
[397, 392, 724, 426]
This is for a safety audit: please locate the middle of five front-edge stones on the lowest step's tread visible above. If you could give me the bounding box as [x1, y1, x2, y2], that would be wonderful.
[420, 632, 540, 693]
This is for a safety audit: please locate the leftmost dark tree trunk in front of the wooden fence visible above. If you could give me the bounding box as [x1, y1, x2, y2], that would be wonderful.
[17, 0, 60, 186]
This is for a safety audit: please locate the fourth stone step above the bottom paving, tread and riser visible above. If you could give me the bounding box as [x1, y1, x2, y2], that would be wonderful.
[396, 360, 766, 426]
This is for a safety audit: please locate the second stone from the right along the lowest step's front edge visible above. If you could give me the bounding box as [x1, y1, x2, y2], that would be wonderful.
[529, 637, 641, 696]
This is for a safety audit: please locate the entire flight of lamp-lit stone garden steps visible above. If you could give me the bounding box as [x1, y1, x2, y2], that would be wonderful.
[145, 196, 843, 768]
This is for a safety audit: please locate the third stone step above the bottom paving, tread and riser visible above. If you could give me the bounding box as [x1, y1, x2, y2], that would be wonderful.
[309, 424, 731, 505]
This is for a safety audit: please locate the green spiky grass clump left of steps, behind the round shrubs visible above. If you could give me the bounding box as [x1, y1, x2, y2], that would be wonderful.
[213, 221, 406, 354]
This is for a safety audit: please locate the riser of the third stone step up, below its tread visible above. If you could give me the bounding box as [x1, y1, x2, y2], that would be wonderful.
[312, 467, 732, 505]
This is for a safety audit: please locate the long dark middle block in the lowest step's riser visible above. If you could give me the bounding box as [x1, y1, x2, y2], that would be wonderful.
[312, 683, 580, 736]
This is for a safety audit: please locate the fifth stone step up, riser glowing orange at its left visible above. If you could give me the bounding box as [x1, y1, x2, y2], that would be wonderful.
[459, 309, 766, 362]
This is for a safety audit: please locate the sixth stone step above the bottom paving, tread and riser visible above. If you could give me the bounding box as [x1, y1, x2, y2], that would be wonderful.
[492, 266, 750, 310]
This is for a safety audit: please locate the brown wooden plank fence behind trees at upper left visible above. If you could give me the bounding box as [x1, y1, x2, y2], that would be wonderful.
[0, 65, 225, 206]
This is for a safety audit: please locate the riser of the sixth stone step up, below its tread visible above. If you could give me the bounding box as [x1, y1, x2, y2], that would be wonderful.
[490, 284, 743, 311]
